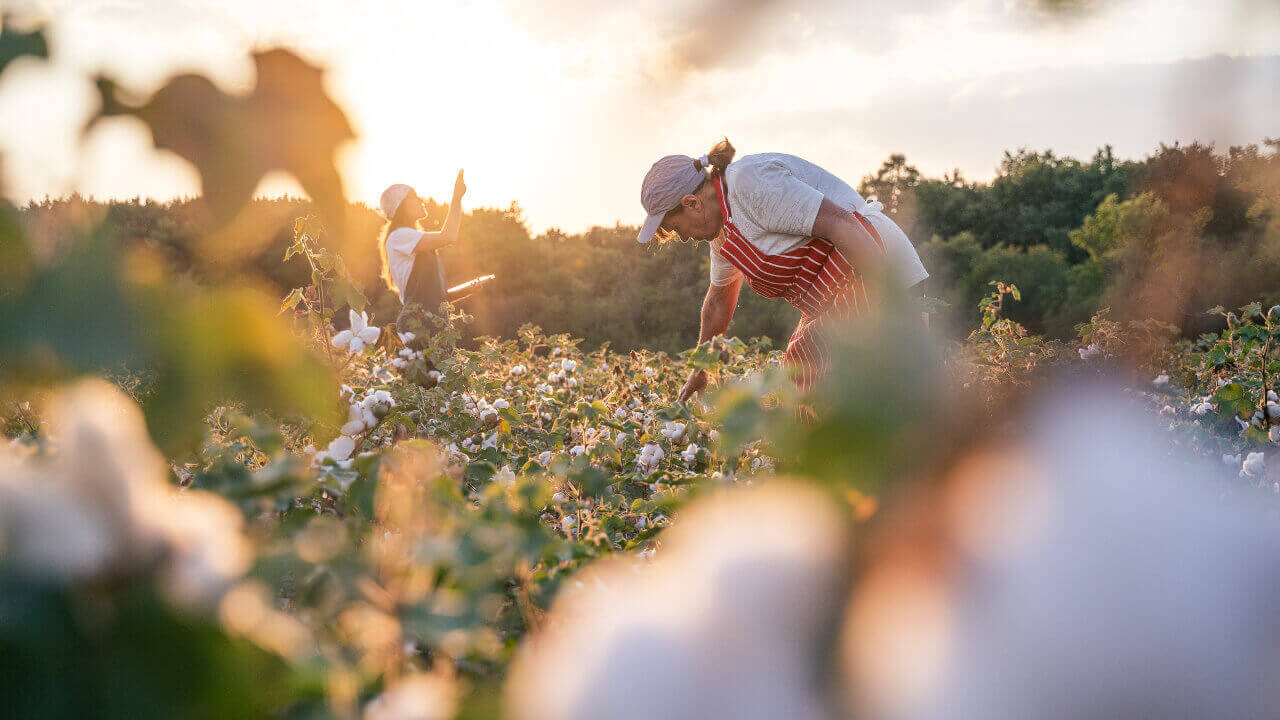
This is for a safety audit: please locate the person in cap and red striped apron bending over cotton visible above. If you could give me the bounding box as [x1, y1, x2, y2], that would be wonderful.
[637, 140, 929, 400]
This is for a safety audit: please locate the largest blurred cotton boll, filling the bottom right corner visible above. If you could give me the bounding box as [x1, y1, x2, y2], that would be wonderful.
[842, 379, 1280, 720]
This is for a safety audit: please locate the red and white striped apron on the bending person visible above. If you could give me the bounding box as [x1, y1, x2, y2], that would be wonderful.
[714, 177, 884, 392]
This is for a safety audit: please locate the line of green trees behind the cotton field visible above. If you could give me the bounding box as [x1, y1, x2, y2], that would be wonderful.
[22, 141, 1280, 352]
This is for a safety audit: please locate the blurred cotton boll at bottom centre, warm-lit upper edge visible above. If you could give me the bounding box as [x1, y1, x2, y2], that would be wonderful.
[507, 482, 849, 720]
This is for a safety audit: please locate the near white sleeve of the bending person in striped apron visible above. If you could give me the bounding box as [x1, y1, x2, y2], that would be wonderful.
[730, 160, 822, 237]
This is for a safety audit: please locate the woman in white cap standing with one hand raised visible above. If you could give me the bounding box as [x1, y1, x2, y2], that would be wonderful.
[378, 170, 467, 325]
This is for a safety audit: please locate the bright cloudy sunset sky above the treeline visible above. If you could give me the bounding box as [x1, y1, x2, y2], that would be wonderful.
[0, 0, 1280, 232]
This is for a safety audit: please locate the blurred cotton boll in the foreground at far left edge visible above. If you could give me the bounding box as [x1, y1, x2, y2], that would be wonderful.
[0, 380, 251, 606]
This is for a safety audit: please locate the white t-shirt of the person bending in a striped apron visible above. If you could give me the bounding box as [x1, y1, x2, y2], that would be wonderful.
[710, 152, 929, 287]
